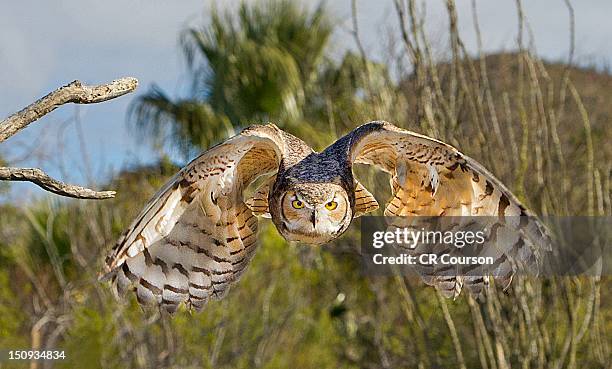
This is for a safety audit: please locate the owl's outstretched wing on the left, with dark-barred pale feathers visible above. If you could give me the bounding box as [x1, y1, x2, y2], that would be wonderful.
[102, 125, 284, 312]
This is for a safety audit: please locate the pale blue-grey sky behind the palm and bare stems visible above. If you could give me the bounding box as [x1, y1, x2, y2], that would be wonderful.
[0, 0, 612, 202]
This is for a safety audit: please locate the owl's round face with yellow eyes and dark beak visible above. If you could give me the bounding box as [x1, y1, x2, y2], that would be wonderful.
[271, 183, 352, 244]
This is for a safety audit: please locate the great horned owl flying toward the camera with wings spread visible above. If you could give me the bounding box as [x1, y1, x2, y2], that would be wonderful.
[100, 122, 544, 312]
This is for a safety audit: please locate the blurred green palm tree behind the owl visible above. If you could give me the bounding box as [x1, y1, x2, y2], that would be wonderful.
[130, 0, 333, 150]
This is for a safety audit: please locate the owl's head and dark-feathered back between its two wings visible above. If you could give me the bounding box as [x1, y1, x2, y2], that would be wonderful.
[268, 132, 355, 244]
